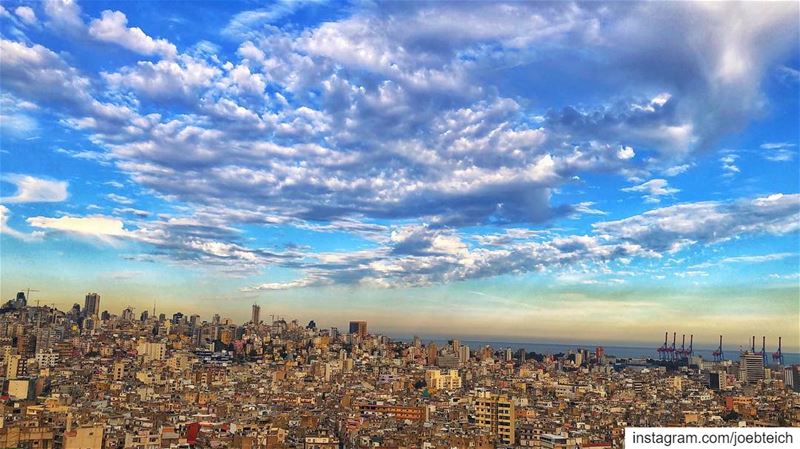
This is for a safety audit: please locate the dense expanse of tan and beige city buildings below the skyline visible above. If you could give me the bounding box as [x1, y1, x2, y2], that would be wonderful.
[0, 294, 800, 449]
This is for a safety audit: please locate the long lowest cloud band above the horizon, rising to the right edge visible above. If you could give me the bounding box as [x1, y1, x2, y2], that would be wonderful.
[245, 194, 800, 291]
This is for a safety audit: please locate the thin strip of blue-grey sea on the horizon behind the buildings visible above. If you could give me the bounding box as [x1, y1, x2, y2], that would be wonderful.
[391, 335, 800, 365]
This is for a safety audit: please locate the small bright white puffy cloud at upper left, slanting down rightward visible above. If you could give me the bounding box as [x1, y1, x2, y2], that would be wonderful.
[89, 10, 178, 58]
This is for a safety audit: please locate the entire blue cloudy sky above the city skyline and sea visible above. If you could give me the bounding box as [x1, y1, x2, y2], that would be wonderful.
[0, 0, 800, 351]
